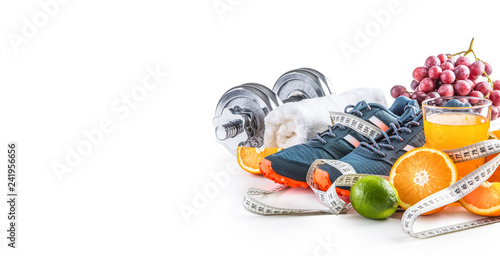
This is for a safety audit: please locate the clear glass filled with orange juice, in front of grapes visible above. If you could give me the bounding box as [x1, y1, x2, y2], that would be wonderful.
[422, 96, 491, 177]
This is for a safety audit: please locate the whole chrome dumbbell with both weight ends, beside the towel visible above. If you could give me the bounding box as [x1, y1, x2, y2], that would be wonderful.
[213, 68, 331, 154]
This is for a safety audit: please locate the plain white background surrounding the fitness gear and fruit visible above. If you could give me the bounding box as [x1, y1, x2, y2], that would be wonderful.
[0, 0, 500, 255]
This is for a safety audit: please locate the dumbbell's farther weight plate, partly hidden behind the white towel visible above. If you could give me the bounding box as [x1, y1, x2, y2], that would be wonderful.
[273, 68, 332, 103]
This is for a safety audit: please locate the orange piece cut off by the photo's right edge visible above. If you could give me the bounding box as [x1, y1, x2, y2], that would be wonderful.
[459, 181, 500, 217]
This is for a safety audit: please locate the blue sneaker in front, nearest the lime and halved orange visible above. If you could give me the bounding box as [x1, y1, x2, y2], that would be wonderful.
[313, 103, 425, 191]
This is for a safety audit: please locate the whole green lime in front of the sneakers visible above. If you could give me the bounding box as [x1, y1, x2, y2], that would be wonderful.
[350, 176, 399, 220]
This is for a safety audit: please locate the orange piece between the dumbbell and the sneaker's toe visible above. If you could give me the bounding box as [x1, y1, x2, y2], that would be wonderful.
[236, 146, 283, 174]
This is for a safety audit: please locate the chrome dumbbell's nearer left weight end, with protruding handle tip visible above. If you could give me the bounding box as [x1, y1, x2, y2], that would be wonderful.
[213, 83, 281, 154]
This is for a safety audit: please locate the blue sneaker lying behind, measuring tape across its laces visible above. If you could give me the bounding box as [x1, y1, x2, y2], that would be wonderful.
[259, 97, 418, 188]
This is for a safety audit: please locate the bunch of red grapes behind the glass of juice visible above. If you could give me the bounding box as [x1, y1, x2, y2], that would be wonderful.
[391, 46, 500, 120]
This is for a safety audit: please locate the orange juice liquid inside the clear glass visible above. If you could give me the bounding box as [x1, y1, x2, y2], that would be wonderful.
[424, 113, 490, 177]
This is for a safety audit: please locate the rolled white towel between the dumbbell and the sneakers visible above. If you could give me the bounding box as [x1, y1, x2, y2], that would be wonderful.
[264, 88, 387, 148]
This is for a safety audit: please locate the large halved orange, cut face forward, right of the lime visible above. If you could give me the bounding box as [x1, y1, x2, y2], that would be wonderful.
[389, 147, 457, 215]
